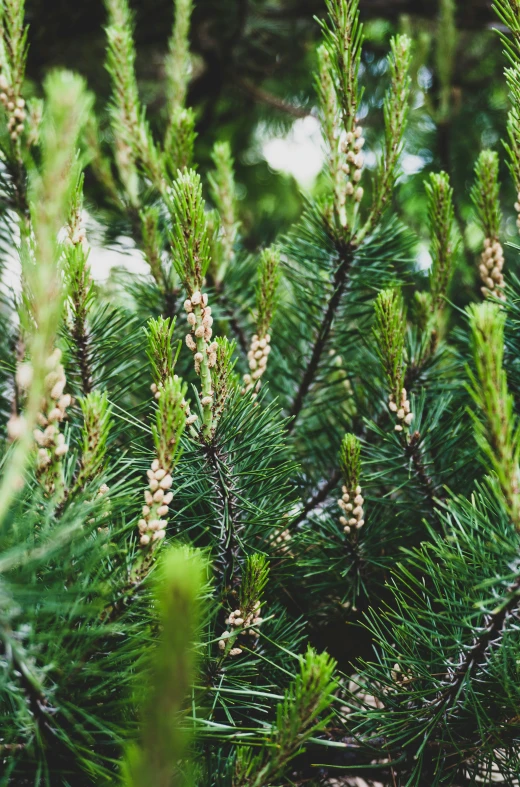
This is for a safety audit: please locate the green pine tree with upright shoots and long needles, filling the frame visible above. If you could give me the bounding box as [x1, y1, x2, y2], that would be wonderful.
[0, 0, 520, 787]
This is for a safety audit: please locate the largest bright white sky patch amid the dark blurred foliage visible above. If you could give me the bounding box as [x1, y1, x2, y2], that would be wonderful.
[260, 115, 325, 189]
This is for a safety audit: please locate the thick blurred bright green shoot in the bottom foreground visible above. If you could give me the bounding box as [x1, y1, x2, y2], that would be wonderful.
[122, 546, 208, 787]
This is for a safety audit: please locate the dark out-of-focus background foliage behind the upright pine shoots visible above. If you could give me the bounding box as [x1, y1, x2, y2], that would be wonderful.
[22, 0, 517, 306]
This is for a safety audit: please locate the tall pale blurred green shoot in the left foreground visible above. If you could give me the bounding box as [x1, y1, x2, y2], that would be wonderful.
[0, 71, 91, 521]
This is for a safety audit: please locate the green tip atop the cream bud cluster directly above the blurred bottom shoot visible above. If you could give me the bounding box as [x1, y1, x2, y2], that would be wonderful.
[152, 376, 187, 473]
